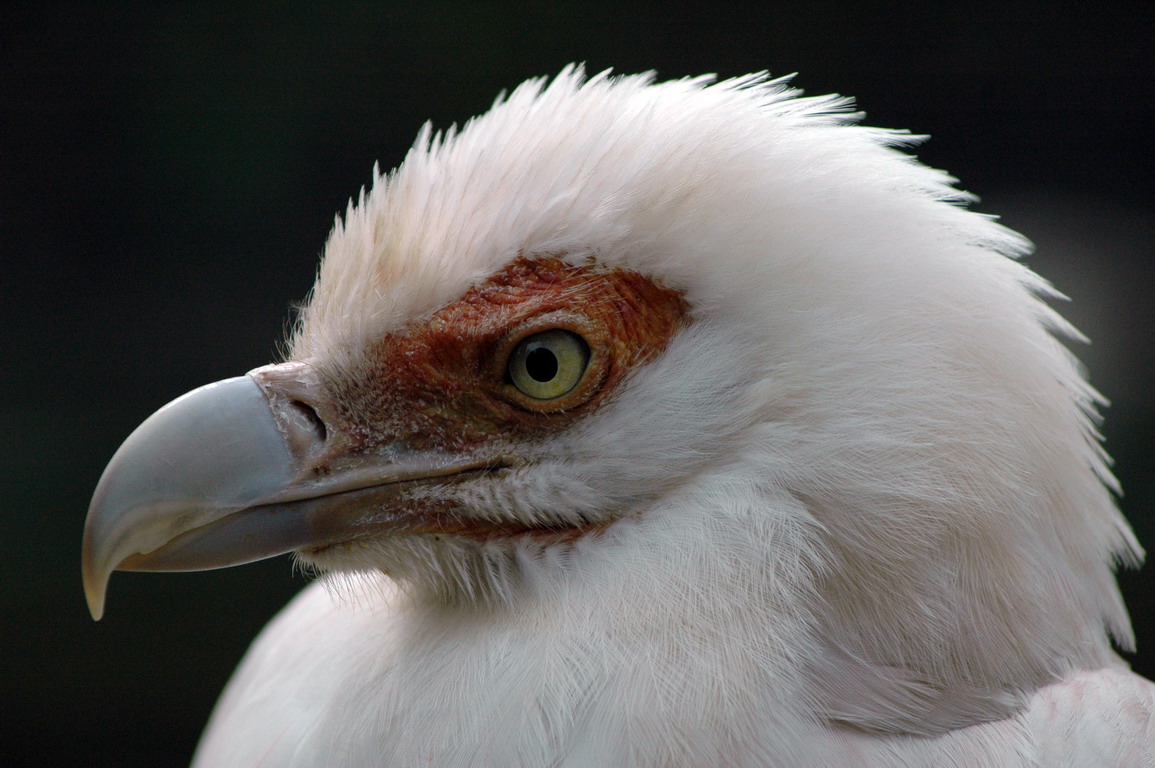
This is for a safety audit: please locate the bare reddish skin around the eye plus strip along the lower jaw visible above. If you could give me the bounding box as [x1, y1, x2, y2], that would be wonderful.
[277, 256, 688, 545]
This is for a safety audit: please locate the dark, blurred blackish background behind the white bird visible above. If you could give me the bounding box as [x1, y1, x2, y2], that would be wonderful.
[0, 2, 1155, 766]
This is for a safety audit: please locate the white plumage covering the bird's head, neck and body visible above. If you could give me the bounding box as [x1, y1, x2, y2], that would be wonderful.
[199, 68, 1155, 767]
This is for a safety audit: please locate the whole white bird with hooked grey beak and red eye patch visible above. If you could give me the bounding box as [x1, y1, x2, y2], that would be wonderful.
[83, 66, 1155, 768]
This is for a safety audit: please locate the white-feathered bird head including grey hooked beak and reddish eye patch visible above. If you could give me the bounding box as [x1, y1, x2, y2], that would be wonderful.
[84, 68, 1140, 730]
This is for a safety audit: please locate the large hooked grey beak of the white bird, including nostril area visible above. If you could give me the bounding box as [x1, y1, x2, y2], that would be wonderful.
[82, 363, 480, 619]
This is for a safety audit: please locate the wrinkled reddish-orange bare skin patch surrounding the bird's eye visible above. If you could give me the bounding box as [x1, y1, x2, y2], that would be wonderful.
[333, 258, 688, 454]
